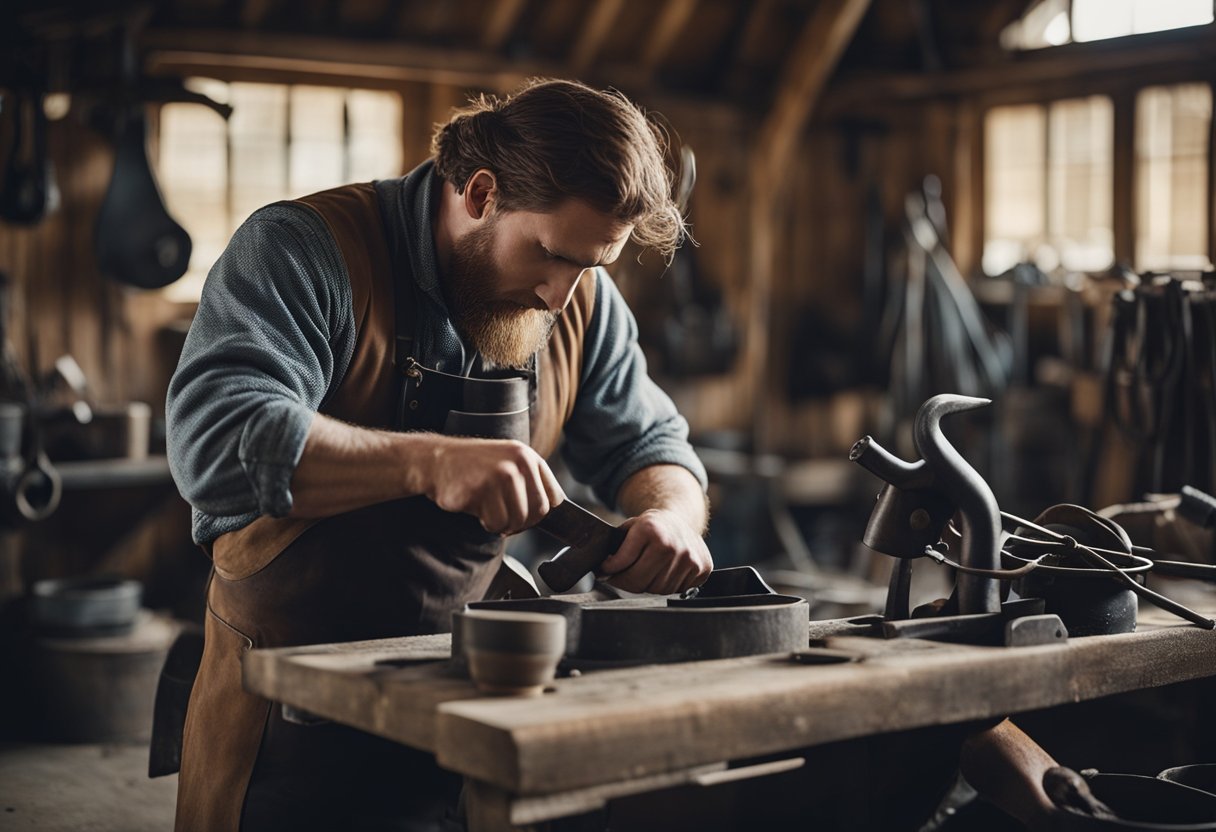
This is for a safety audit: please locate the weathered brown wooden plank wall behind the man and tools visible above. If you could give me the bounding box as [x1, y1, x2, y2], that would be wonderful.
[7, 29, 1216, 600]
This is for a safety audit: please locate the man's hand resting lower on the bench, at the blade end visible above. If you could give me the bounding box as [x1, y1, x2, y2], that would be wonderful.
[599, 508, 714, 595]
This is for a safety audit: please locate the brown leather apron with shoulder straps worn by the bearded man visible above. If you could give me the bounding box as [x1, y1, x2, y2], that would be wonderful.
[176, 184, 595, 832]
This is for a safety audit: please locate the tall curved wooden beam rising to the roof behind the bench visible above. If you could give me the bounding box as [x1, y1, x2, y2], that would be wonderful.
[743, 0, 869, 452]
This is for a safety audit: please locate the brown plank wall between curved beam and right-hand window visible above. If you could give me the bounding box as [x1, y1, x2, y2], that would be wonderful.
[744, 103, 970, 459]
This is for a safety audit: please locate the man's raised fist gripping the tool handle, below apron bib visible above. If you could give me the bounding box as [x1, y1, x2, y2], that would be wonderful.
[423, 437, 565, 535]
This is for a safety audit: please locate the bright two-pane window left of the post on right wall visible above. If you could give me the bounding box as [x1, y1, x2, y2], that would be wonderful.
[983, 96, 1114, 275]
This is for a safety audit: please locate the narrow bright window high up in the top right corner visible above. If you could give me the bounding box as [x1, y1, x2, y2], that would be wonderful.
[1001, 0, 1212, 51]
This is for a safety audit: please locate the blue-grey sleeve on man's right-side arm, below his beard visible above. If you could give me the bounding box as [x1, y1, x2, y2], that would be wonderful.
[562, 270, 706, 506]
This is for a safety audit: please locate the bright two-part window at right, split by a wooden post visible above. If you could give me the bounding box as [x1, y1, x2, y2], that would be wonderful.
[983, 84, 1212, 275]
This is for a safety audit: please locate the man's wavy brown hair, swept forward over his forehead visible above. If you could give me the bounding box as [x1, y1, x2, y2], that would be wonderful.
[430, 79, 687, 257]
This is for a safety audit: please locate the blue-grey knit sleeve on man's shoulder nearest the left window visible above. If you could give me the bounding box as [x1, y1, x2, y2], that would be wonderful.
[165, 203, 355, 525]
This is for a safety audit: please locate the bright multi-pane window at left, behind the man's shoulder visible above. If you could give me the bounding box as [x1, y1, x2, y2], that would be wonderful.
[157, 79, 402, 300]
